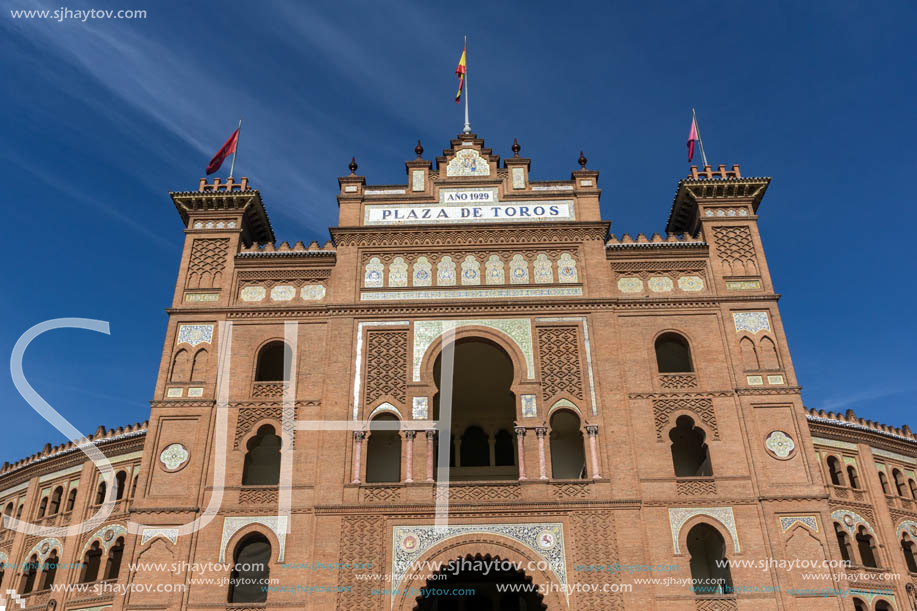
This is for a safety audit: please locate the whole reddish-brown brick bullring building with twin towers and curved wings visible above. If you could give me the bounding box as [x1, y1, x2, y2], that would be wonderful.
[0, 134, 917, 611]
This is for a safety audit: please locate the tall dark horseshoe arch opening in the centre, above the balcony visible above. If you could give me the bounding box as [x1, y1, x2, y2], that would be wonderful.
[433, 337, 519, 481]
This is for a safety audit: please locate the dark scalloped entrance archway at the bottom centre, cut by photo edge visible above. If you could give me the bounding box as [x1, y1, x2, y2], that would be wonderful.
[413, 554, 548, 611]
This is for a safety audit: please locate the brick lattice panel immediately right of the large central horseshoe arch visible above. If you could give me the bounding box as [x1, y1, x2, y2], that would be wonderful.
[538, 327, 583, 401]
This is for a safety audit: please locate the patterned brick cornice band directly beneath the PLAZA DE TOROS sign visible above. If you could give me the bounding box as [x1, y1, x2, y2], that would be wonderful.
[329, 221, 611, 248]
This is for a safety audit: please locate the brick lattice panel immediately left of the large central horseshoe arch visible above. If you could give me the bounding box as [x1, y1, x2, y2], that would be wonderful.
[365, 330, 408, 405]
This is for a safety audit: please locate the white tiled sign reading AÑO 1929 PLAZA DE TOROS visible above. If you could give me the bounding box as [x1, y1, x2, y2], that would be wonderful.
[363, 189, 576, 225]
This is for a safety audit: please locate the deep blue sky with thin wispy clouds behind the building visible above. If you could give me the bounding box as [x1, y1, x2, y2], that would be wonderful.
[0, 0, 917, 461]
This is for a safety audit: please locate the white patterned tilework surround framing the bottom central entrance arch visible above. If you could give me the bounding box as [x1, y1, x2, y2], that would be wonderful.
[392, 522, 567, 604]
